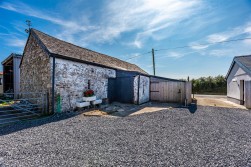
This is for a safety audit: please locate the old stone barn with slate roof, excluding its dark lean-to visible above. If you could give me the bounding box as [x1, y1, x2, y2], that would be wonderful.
[20, 29, 151, 111]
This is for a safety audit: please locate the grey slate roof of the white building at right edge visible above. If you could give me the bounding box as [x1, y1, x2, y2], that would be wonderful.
[226, 55, 251, 78]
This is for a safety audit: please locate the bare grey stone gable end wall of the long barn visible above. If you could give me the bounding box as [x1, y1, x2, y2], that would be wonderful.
[20, 35, 51, 96]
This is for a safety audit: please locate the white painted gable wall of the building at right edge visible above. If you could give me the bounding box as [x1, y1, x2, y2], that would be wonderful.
[227, 63, 251, 100]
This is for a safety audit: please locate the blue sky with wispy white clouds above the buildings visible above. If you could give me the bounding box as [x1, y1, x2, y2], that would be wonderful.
[0, 0, 251, 79]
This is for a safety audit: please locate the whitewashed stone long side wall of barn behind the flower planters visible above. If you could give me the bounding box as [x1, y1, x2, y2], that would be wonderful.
[51, 59, 116, 112]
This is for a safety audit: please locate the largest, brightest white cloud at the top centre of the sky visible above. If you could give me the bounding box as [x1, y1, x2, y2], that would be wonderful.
[81, 0, 201, 48]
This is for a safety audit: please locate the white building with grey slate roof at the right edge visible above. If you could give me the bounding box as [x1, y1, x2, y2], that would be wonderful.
[226, 55, 251, 108]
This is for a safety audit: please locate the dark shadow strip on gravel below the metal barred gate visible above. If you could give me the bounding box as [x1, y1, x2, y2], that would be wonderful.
[0, 113, 78, 136]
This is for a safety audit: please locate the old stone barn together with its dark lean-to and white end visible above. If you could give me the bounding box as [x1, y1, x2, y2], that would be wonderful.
[20, 29, 192, 112]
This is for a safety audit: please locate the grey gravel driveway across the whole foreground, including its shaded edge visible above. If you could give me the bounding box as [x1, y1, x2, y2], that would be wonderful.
[0, 106, 251, 166]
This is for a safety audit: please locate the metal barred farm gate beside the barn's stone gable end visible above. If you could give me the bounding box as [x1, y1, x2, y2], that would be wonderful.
[0, 93, 48, 125]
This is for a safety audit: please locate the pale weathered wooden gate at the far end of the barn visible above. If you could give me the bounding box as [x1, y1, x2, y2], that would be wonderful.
[150, 81, 186, 103]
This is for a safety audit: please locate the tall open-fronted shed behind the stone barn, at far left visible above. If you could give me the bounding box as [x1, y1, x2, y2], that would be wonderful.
[2, 53, 22, 93]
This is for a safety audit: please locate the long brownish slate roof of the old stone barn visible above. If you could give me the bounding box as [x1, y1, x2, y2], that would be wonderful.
[31, 28, 147, 74]
